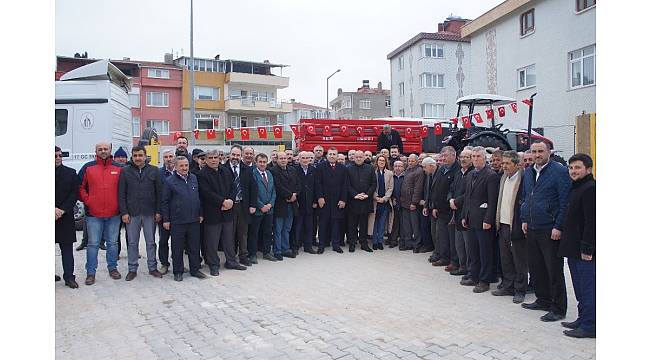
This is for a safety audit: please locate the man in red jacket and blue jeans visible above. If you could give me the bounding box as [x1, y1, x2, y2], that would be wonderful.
[79, 142, 122, 285]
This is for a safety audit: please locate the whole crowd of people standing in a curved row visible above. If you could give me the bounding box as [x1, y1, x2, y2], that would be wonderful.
[55, 129, 596, 337]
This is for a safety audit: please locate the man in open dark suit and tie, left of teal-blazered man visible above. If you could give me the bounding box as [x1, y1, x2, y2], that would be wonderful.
[221, 144, 257, 266]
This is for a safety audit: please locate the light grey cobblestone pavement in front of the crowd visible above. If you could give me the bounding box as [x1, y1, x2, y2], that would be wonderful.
[55, 233, 596, 360]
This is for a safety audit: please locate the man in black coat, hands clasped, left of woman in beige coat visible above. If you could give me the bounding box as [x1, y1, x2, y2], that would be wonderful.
[347, 151, 377, 252]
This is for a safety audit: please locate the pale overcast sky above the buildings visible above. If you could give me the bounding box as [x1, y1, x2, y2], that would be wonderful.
[55, 0, 502, 106]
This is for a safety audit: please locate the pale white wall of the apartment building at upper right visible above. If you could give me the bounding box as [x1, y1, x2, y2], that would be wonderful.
[470, 0, 598, 158]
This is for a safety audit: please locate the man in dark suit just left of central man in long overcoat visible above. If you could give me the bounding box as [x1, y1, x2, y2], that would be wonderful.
[291, 151, 318, 254]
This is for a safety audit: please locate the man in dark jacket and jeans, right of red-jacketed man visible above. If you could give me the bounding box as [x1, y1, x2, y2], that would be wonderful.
[118, 146, 162, 281]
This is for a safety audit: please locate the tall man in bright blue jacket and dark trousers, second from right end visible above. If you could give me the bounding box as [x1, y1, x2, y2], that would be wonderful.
[520, 142, 571, 321]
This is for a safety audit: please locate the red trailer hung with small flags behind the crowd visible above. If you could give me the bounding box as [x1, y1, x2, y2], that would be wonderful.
[296, 119, 431, 154]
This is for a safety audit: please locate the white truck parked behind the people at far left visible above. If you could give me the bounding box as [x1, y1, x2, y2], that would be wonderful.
[54, 60, 132, 171]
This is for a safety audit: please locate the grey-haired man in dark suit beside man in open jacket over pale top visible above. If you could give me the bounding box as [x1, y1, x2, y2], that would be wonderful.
[461, 146, 499, 293]
